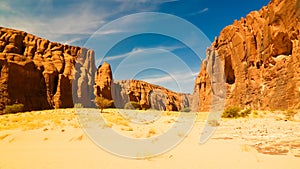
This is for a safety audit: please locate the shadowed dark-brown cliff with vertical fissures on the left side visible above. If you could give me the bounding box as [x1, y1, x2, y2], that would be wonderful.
[0, 27, 95, 110]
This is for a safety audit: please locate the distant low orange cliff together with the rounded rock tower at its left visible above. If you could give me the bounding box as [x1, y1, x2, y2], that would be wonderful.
[94, 62, 191, 111]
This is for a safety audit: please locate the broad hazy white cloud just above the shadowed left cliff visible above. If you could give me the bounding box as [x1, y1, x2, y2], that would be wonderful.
[0, 2, 107, 41]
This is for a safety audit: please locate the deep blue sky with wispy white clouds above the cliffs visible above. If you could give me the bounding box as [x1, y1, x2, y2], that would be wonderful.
[0, 0, 268, 92]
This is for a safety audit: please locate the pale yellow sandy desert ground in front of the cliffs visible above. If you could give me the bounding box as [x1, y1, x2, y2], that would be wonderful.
[0, 109, 300, 169]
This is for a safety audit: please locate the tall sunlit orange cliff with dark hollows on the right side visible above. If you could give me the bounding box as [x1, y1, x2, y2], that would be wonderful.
[194, 0, 300, 111]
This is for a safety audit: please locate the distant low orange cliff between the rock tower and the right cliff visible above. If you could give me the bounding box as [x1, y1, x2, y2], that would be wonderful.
[112, 80, 191, 111]
